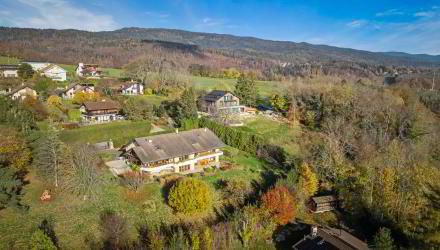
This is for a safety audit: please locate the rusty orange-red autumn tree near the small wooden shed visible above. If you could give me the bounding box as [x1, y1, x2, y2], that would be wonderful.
[261, 187, 295, 225]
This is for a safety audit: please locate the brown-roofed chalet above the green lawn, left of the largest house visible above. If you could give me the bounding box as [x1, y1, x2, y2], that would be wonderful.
[79, 101, 125, 123]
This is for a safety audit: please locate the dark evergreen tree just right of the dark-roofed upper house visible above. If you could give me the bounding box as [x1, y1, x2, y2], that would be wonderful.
[234, 75, 258, 106]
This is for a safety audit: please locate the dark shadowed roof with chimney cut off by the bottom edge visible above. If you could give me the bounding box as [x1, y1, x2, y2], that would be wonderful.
[292, 226, 368, 250]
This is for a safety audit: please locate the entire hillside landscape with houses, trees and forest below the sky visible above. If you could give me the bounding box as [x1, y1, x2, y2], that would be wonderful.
[0, 12, 440, 250]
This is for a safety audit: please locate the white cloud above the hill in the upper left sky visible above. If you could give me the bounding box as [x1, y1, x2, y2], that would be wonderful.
[8, 0, 118, 31]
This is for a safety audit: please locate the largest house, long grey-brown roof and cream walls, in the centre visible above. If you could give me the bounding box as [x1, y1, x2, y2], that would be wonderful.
[121, 128, 225, 175]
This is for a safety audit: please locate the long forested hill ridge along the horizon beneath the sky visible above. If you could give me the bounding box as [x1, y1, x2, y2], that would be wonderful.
[0, 27, 440, 77]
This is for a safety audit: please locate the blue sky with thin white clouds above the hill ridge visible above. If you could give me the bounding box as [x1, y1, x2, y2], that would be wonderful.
[0, 0, 440, 54]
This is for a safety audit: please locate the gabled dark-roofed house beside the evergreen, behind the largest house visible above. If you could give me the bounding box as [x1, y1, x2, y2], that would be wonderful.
[200, 90, 245, 115]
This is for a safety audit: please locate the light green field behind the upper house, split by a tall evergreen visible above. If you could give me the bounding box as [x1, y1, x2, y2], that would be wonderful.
[191, 76, 284, 96]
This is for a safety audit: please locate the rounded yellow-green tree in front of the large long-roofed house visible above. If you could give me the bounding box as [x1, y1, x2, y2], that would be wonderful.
[168, 178, 212, 214]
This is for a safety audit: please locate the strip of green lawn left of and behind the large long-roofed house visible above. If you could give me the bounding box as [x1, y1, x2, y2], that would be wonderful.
[61, 121, 151, 147]
